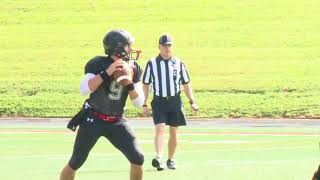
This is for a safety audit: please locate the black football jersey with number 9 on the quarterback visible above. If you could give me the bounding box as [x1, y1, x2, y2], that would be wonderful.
[85, 56, 142, 116]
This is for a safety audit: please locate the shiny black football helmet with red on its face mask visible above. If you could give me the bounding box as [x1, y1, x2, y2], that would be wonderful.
[103, 29, 139, 60]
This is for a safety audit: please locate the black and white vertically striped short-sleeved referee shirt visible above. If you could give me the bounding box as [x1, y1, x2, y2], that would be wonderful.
[142, 55, 190, 97]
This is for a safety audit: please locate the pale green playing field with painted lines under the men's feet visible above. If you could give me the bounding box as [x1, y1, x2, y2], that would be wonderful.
[0, 125, 320, 180]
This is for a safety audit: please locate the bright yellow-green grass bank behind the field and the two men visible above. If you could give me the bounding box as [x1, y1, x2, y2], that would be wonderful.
[0, 0, 320, 118]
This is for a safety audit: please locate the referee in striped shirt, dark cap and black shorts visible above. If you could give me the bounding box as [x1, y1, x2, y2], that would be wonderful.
[142, 34, 198, 171]
